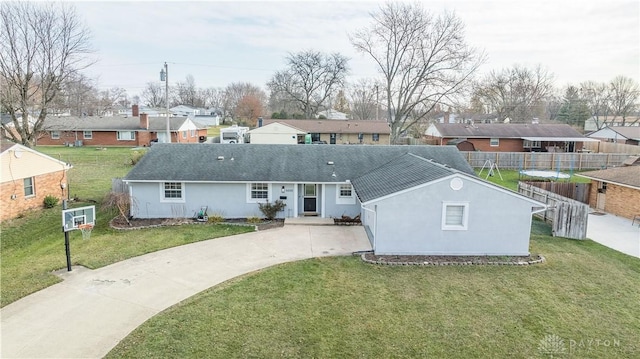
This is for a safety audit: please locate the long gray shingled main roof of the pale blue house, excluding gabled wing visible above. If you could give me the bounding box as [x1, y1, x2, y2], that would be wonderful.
[125, 143, 475, 183]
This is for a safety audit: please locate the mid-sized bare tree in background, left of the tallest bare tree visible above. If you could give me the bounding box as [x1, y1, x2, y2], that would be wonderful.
[267, 50, 349, 118]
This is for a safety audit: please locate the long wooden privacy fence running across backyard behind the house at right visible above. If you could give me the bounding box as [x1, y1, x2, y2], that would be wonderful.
[460, 151, 629, 171]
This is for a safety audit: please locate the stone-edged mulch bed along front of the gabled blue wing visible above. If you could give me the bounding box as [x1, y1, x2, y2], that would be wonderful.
[361, 253, 545, 266]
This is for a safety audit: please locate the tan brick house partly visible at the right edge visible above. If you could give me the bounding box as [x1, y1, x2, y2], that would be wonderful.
[577, 165, 640, 219]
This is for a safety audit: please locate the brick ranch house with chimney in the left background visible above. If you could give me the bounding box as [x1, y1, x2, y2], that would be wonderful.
[36, 105, 207, 147]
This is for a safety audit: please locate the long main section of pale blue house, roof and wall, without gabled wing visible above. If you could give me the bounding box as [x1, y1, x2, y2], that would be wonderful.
[124, 143, 474, 222]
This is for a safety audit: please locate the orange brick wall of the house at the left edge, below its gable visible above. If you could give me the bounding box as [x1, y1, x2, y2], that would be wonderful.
[0, 171, 68, 225]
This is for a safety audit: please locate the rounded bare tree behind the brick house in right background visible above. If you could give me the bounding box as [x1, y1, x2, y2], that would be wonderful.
[475, 65, 553, 123]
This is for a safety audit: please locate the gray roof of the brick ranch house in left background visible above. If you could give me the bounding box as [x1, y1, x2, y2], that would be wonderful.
[42, 116, 204, 131]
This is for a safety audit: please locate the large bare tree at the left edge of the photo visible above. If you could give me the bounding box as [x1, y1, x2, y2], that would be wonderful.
[0, 2, 91, 147]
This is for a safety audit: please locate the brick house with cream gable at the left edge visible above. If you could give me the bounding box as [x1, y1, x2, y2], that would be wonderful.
[0, 140, 71, 221]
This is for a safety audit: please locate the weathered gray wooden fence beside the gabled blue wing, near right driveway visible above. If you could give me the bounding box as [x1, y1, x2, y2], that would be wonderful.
[518, 182, 589, 239]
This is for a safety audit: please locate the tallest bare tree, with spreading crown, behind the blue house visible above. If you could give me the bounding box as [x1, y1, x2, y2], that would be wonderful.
[351, 2, 484, 143]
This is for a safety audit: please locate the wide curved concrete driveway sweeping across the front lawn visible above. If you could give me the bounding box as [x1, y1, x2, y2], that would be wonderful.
[0, 225, 371, 358]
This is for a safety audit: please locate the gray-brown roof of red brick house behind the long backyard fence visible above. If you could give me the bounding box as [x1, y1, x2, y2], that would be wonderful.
[434, 123, 586, 139]
